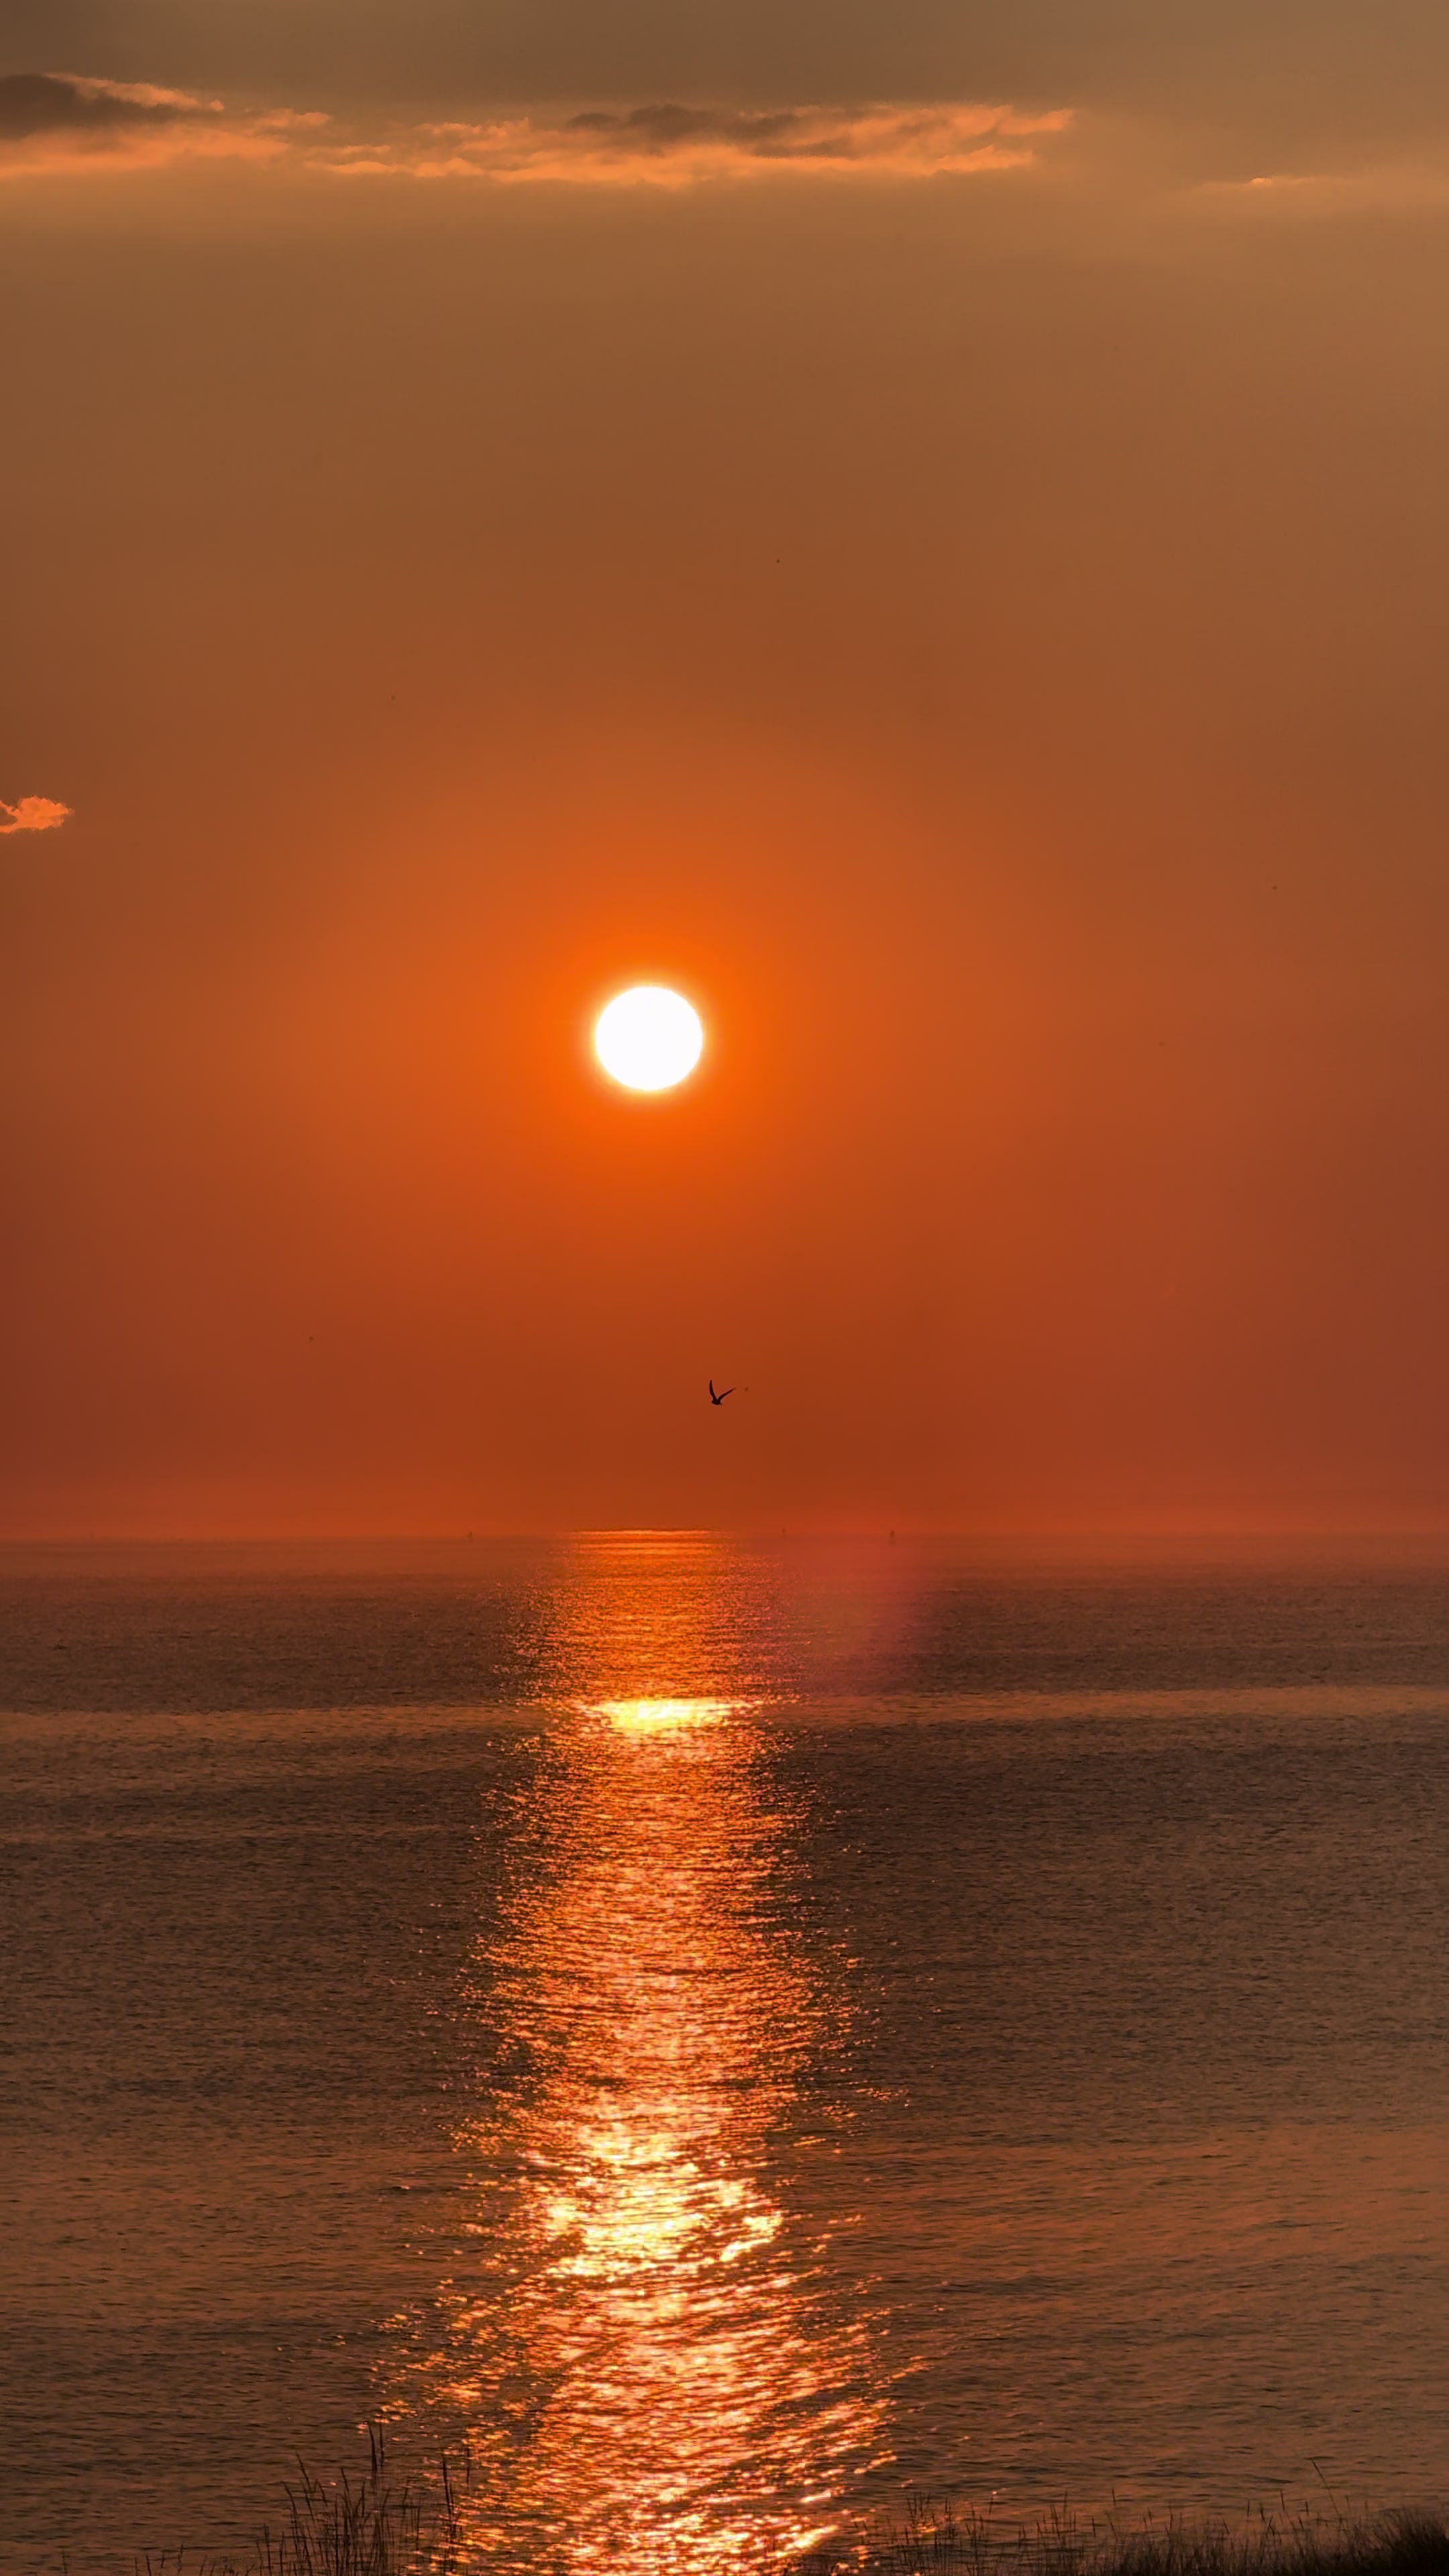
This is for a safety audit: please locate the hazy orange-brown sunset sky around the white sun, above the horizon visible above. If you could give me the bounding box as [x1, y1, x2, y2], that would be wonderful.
[0, 0, 1449, 1536]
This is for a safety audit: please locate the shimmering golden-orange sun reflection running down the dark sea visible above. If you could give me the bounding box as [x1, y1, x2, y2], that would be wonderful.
[381, 1556, 881, 2576]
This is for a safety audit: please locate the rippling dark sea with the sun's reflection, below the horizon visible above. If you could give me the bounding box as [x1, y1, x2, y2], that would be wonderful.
[0, 1536, 1449, 2576]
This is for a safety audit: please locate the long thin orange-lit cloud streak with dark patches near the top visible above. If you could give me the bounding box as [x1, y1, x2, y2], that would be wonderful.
[0, 72, 1073, 188]
